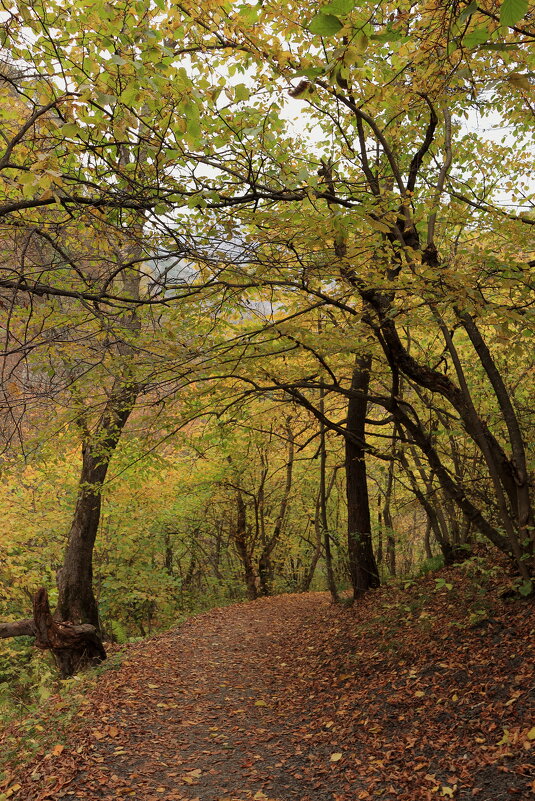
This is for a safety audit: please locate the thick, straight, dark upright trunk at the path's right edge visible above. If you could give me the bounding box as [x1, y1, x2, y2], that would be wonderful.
[345, 354, 379, 598]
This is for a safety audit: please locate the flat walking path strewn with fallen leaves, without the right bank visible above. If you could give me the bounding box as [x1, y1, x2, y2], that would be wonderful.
[58, 594, 352, 801]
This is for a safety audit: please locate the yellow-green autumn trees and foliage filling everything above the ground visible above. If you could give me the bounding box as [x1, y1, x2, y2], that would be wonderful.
[0, 0, 535, 673]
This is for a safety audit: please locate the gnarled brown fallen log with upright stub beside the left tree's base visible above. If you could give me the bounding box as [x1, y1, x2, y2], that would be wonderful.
[0, 587, 106, 678]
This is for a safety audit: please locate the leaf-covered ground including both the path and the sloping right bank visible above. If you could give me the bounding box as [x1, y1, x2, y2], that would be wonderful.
[0, 556, 535, 801]
